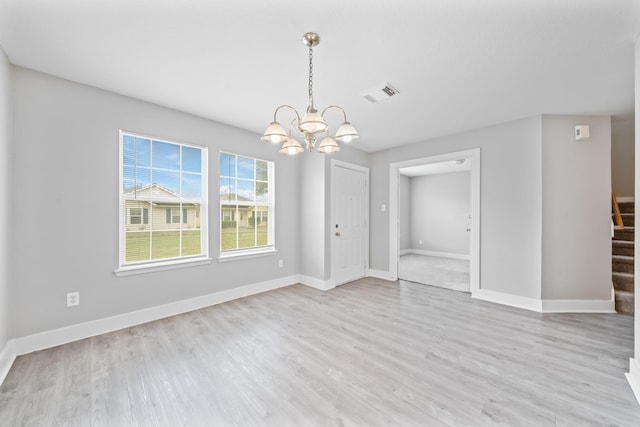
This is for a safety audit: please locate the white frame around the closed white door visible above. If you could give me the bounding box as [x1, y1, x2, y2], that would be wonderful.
[328, 159, 369, 287]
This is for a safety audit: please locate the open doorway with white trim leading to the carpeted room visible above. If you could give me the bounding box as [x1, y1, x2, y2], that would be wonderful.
[389, 149, 480, 293]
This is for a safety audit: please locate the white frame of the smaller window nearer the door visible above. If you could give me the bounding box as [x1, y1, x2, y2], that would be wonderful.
[216, 150, 278, 262]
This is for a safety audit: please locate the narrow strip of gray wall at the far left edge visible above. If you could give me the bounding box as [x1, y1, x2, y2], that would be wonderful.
[0, 47, 13, 351]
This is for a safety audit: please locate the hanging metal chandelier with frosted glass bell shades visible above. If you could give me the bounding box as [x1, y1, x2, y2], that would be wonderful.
[260, 33, 359, 155]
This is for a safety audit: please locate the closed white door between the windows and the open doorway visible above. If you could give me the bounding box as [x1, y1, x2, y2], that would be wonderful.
[331, 164, 368, 285]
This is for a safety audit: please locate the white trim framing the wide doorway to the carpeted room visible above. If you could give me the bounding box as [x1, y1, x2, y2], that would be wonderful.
[389, 148, 480, 296]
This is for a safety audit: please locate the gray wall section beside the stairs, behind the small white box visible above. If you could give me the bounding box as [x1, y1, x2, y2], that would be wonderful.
[542, 115, 611, 300]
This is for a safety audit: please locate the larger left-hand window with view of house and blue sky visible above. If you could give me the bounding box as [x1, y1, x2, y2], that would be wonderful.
[120, 132, 208, 269]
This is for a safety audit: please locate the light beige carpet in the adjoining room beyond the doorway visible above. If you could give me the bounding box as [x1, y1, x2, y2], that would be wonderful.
[398, 254, 470, 292]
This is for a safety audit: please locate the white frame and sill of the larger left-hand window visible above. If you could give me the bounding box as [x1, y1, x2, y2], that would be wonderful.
[114, 130, 211, 276]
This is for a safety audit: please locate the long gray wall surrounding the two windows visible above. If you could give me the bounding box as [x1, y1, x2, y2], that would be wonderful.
[11, 65, 301, 337]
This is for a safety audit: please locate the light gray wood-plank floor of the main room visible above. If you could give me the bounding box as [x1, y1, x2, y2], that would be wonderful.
[0, 278, 640, 426]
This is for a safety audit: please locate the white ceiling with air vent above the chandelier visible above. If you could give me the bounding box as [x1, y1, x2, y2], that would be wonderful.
[0, 0, 640, 152]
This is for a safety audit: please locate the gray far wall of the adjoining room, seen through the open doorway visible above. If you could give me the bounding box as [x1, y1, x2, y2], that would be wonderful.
[410, 172, 471, 255]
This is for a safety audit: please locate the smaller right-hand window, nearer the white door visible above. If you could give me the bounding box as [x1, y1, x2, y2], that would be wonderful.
[220, 152, 274, 255]
